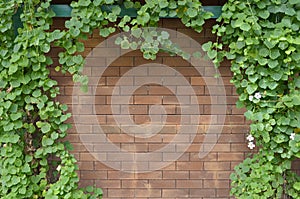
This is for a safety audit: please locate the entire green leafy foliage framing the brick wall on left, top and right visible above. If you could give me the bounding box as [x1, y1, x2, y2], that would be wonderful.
[0, 0, 300, 199]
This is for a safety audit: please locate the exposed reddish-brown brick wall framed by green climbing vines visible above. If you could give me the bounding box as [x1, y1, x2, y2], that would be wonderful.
[49, 0, 299, 199]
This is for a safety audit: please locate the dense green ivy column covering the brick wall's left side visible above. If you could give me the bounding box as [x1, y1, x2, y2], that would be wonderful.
[0, 0, 102, 199]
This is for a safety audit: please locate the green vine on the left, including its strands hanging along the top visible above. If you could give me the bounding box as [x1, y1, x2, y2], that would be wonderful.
[0, 0, 212, 199]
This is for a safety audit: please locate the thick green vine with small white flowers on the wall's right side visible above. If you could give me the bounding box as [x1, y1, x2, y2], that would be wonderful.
[203, 0, 300, 198]
